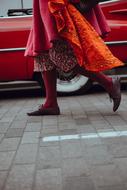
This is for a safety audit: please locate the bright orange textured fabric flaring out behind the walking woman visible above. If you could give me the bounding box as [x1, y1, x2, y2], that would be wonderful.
[48, 0, 123, 72]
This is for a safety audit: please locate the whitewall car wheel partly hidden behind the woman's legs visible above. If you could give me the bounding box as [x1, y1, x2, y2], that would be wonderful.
[57, 72, 92, 95]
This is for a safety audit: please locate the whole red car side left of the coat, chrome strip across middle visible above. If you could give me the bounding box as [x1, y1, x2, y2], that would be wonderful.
[0, 16, 34, 81]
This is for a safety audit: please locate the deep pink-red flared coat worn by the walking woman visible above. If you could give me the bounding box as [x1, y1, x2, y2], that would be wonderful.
[25, 0, 110, 56]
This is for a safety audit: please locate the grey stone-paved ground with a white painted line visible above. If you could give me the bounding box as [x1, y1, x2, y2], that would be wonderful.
[0, 92, 127, 190]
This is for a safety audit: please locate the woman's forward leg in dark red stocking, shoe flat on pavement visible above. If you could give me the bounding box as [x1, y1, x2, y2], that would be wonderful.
[28, 56, 60, 116]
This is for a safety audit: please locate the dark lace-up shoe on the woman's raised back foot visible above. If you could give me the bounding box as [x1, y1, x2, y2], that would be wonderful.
[109, 77, 121, 112]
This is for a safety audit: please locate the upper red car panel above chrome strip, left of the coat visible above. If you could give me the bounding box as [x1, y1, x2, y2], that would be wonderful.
[0, 16, 32, 49]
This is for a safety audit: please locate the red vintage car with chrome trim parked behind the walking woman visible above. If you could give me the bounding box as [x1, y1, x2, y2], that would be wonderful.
[0, 0, 127, 93]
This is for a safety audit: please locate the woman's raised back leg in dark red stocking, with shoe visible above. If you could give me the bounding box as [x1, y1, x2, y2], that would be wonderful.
[74, 65, 121, 112]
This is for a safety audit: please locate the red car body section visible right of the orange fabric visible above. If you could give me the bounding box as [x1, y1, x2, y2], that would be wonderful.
[101, 0, 127, 63]
